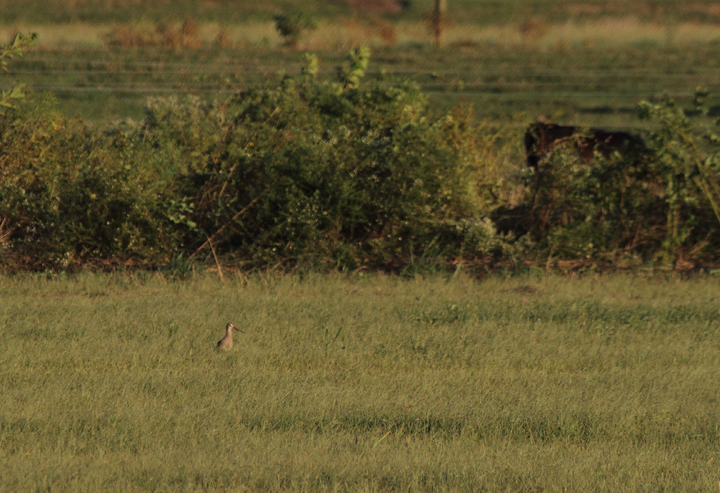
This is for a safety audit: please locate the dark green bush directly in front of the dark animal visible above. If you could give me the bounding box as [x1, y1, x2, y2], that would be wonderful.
[529, 138, 664, 260]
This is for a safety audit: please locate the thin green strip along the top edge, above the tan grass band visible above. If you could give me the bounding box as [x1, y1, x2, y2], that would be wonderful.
[0, 0, 720, 25]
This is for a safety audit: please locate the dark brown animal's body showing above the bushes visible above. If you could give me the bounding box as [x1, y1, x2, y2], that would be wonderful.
[525, 122, 645, 170]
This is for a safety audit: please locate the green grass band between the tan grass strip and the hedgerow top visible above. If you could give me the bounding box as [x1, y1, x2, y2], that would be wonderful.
[5, 40, 720, 128]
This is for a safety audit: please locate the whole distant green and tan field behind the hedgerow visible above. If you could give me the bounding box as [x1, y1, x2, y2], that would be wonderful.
[0, 0, 720, 128]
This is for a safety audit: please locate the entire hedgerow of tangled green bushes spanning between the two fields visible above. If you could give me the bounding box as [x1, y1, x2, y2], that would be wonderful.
[0, 37, 720, 272]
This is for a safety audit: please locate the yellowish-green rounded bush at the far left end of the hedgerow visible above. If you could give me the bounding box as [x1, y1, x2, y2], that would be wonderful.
[0, 97, 175, 268]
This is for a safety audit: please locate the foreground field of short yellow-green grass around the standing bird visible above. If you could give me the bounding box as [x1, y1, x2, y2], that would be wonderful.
[0, 273, 720, 491]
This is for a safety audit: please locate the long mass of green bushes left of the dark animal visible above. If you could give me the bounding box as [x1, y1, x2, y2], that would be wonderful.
[0, 50, 510, 269]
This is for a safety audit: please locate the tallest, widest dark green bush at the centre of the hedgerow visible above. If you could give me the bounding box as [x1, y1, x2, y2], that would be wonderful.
[144, 50, 510, 268]
